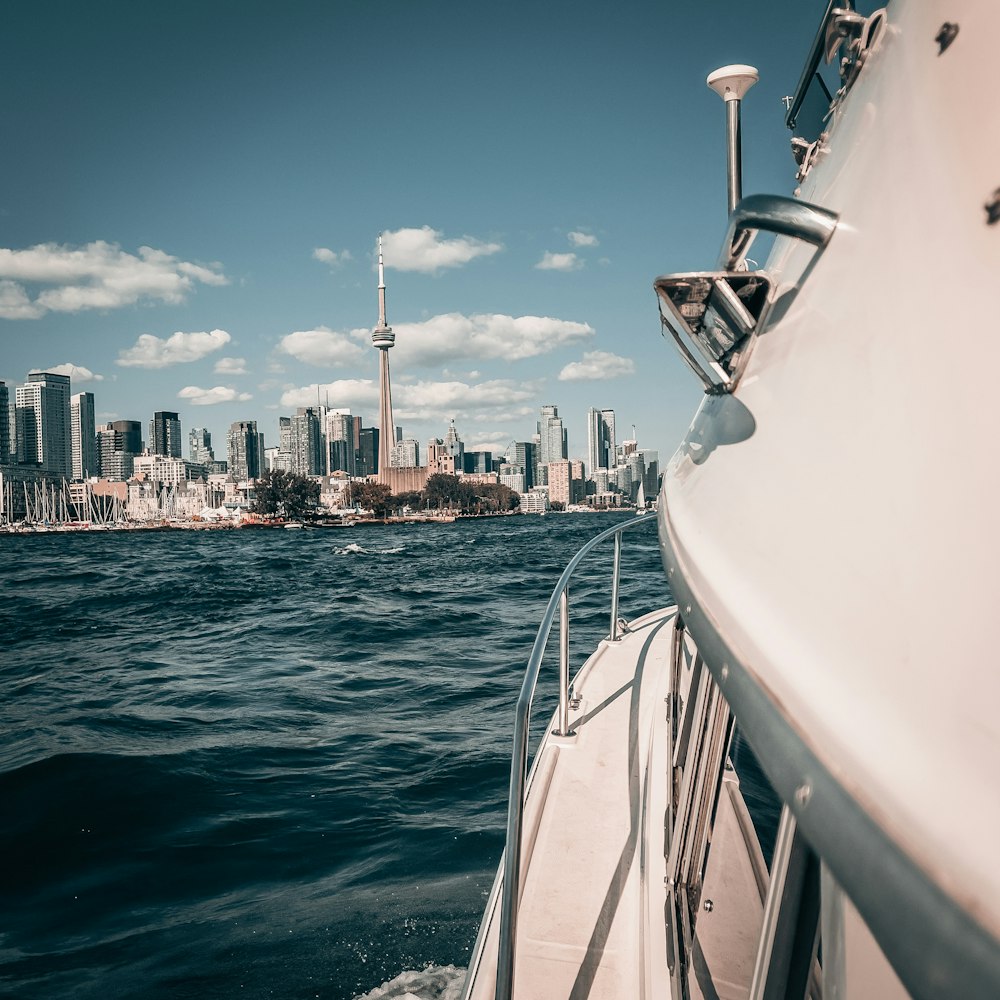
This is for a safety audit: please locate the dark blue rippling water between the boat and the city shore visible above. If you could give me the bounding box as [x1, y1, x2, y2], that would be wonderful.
[0, 514, 669, 1000]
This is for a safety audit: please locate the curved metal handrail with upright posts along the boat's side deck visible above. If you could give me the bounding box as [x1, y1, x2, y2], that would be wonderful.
[495, 515, 656, 1000]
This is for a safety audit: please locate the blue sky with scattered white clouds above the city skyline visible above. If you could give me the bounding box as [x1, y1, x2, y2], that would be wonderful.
[0, 0, 824, 461]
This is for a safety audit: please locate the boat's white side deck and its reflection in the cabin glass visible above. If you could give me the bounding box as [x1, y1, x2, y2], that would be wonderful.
[469, 609, 760, 1000]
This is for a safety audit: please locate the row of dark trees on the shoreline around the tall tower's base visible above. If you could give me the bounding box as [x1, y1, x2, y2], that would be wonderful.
[250, 469, 521, 518]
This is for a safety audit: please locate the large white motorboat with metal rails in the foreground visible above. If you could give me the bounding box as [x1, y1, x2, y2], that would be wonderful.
[464, 0, 1000, 1000]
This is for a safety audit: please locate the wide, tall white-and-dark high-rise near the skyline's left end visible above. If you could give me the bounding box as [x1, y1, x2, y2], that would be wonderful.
[16, 372, 73, 477]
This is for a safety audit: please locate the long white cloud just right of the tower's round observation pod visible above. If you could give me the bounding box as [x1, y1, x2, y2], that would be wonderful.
[391, 313, 594, 365]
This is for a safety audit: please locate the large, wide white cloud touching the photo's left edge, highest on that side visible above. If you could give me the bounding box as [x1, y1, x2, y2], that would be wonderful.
[0, 240, 227, 319]
